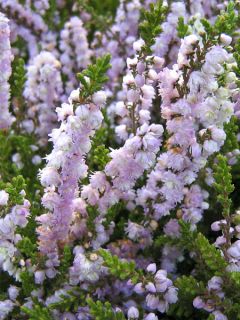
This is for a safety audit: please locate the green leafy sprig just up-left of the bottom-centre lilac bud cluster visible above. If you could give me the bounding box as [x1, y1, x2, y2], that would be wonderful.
[98, 249, 142, 283]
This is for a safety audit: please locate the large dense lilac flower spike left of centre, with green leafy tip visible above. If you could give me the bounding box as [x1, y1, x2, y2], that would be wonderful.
[37, 56, 110, 270]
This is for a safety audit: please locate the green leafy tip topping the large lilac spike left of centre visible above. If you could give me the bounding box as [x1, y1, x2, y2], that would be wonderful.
[77, 54, 111, 101]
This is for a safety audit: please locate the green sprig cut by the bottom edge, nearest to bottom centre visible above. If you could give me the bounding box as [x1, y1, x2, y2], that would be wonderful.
[87, 298, 126, 320]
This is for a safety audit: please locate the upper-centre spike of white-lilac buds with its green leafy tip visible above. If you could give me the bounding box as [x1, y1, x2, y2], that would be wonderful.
[108, 1, 166, 137]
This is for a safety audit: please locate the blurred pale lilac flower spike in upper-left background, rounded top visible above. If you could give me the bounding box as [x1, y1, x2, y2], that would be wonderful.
[22, 51, 63, 145]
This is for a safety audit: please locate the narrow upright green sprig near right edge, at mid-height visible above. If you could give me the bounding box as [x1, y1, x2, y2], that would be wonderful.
[214, 155, 234, 218]
